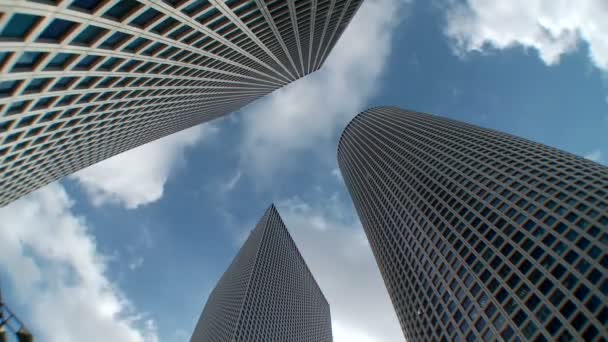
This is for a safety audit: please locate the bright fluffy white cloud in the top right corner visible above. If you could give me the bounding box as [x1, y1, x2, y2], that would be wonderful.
[445, 0, 608, 70]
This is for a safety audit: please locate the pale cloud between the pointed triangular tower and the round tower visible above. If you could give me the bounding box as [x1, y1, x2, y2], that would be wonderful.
[277, 194, 404, 342]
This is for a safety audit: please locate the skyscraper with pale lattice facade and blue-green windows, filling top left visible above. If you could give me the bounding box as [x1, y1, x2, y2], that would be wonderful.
[0, 0, 361, 206]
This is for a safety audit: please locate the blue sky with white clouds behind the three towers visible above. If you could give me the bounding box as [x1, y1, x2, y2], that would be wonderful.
[0, 0, 608, 342]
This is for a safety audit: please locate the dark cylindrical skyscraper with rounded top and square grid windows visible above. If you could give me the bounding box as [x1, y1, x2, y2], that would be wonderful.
[338, 107, 608, 341]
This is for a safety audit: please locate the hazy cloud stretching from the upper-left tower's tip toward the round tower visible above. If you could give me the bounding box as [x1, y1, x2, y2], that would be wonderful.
[242, 0, 407, 180]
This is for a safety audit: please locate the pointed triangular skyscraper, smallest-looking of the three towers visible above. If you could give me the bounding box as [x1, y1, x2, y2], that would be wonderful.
[190, 206, 332, 342]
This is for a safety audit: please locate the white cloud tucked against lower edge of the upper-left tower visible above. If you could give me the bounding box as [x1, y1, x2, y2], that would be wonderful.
[70, 124, 218, 209]
